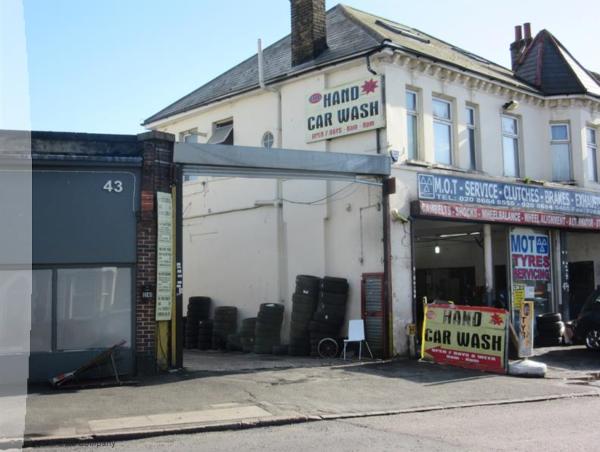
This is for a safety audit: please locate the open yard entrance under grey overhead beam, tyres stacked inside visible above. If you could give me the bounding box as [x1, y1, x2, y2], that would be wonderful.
[174, 143, 390, 366]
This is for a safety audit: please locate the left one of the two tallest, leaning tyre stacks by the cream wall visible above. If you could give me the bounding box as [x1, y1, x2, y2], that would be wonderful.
[288, 275, 321, 356]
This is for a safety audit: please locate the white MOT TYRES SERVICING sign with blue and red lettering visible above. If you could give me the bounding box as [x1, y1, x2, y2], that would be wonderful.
[509, 228, 551, 282]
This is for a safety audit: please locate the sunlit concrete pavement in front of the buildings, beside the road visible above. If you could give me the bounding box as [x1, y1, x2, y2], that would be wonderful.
[12, 351, 600, 444]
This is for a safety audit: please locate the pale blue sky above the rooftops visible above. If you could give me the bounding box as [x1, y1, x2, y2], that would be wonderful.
[16, 0, 600, 133]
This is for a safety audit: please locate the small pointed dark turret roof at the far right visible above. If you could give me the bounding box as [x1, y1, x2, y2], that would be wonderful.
[515, 30, 600, 96]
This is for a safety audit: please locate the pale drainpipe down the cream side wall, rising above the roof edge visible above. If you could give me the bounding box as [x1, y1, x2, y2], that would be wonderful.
[257, 39, 287, 302]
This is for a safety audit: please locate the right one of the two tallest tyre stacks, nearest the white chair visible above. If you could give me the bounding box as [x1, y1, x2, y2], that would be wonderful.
[308, 276, 349, 356]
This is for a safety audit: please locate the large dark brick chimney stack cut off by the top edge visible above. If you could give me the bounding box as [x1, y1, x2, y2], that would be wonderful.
[290, 0, 327, 66]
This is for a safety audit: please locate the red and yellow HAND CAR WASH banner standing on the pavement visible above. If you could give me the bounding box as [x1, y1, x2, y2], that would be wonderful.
[421, 304, 508, 373]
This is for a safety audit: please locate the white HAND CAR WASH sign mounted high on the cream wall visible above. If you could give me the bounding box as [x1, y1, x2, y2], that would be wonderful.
[304, 77, 385, 143]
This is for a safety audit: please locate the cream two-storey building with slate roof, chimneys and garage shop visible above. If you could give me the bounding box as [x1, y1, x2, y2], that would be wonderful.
[144, 0, 600, 354]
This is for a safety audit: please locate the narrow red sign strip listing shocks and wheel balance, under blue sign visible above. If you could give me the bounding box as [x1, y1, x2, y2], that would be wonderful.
[412, 201, 600, 230]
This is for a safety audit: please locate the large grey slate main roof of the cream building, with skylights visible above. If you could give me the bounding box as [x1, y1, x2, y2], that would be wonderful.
[143, 5, 591, 125]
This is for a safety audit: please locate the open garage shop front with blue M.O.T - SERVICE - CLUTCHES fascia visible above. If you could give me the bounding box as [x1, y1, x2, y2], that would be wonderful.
[411, 173, 600, 334]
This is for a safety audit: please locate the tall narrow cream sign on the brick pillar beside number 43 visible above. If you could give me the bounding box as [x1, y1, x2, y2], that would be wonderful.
[156, 192, 173, 320]
